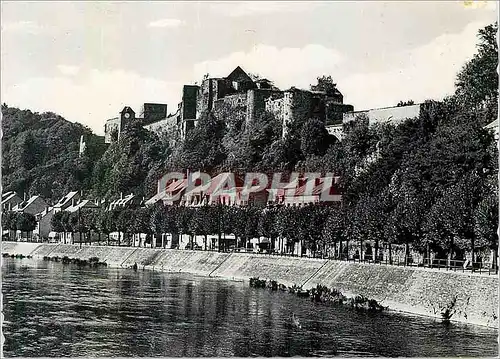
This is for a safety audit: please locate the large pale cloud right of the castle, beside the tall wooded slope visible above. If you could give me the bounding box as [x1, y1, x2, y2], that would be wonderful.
[338, 23, 487, 109]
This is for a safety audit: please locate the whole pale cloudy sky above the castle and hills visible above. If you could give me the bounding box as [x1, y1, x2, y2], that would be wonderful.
[0, 1, 498, 134]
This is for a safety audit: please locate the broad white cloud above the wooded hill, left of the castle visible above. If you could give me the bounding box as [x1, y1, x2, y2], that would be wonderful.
[2, 70, 182, 134]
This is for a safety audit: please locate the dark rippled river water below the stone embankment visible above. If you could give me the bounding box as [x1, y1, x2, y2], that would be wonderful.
[2, 258, 498, 357]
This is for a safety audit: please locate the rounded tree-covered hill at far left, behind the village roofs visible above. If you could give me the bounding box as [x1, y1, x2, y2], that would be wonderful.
[2, 104, 106, 202]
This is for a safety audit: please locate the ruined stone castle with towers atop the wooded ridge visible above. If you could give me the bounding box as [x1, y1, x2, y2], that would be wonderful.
[105, 66, 354, 143]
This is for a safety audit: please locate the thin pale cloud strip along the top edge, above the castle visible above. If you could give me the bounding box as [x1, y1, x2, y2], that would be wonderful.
[211, 1, 318, 17]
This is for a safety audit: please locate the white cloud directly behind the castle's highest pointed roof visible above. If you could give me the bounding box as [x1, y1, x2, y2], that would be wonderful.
[194, 44, 342, 88]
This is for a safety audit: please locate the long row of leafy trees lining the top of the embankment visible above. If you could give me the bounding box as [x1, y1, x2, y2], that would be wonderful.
[43, 194, 498, 268]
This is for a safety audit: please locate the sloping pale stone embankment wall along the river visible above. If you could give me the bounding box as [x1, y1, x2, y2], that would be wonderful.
[2, 242, 498, 328]
